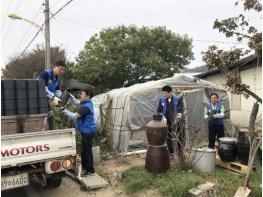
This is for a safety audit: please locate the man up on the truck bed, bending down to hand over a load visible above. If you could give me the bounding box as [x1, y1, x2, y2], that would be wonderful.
[37, 60, 66, 129]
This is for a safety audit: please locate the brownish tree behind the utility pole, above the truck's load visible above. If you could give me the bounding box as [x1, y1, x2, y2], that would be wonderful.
[2, 45, 72, 79]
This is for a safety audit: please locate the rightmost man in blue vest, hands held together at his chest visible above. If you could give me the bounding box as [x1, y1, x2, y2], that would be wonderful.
[204, 93, 225, 149]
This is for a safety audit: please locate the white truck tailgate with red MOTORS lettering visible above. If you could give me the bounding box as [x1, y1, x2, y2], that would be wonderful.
[1, 128, 76, 169]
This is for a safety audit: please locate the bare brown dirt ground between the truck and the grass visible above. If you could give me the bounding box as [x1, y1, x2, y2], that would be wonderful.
[2, 155, 159, 197]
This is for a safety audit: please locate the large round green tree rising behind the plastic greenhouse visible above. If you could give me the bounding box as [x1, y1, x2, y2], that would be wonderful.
[73, 26, 193, 90]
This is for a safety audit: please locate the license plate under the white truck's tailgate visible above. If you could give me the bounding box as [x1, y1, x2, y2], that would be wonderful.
[1, 173, 29, 190]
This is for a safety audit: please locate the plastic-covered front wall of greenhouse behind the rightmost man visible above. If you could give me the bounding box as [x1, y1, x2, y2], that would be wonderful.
[182, 87, 232, 147]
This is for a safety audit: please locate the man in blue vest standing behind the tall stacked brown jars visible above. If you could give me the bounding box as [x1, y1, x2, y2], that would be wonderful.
[157, 85, 179, 159]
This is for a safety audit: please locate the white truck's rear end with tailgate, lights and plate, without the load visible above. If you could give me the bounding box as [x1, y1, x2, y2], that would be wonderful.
[1, 128, 77, 191]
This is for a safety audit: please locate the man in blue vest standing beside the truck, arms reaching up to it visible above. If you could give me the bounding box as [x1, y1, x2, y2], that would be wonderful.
[61, 89, 96, 176]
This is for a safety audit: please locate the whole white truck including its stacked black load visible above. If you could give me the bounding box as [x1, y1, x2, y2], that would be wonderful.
[1, 79, 77, 190]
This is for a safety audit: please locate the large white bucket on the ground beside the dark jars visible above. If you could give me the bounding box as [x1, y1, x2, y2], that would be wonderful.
[191, 148, 216, 172]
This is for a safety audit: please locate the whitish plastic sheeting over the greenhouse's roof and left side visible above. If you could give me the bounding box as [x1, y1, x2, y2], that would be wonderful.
[92, 75, 229, 151]
